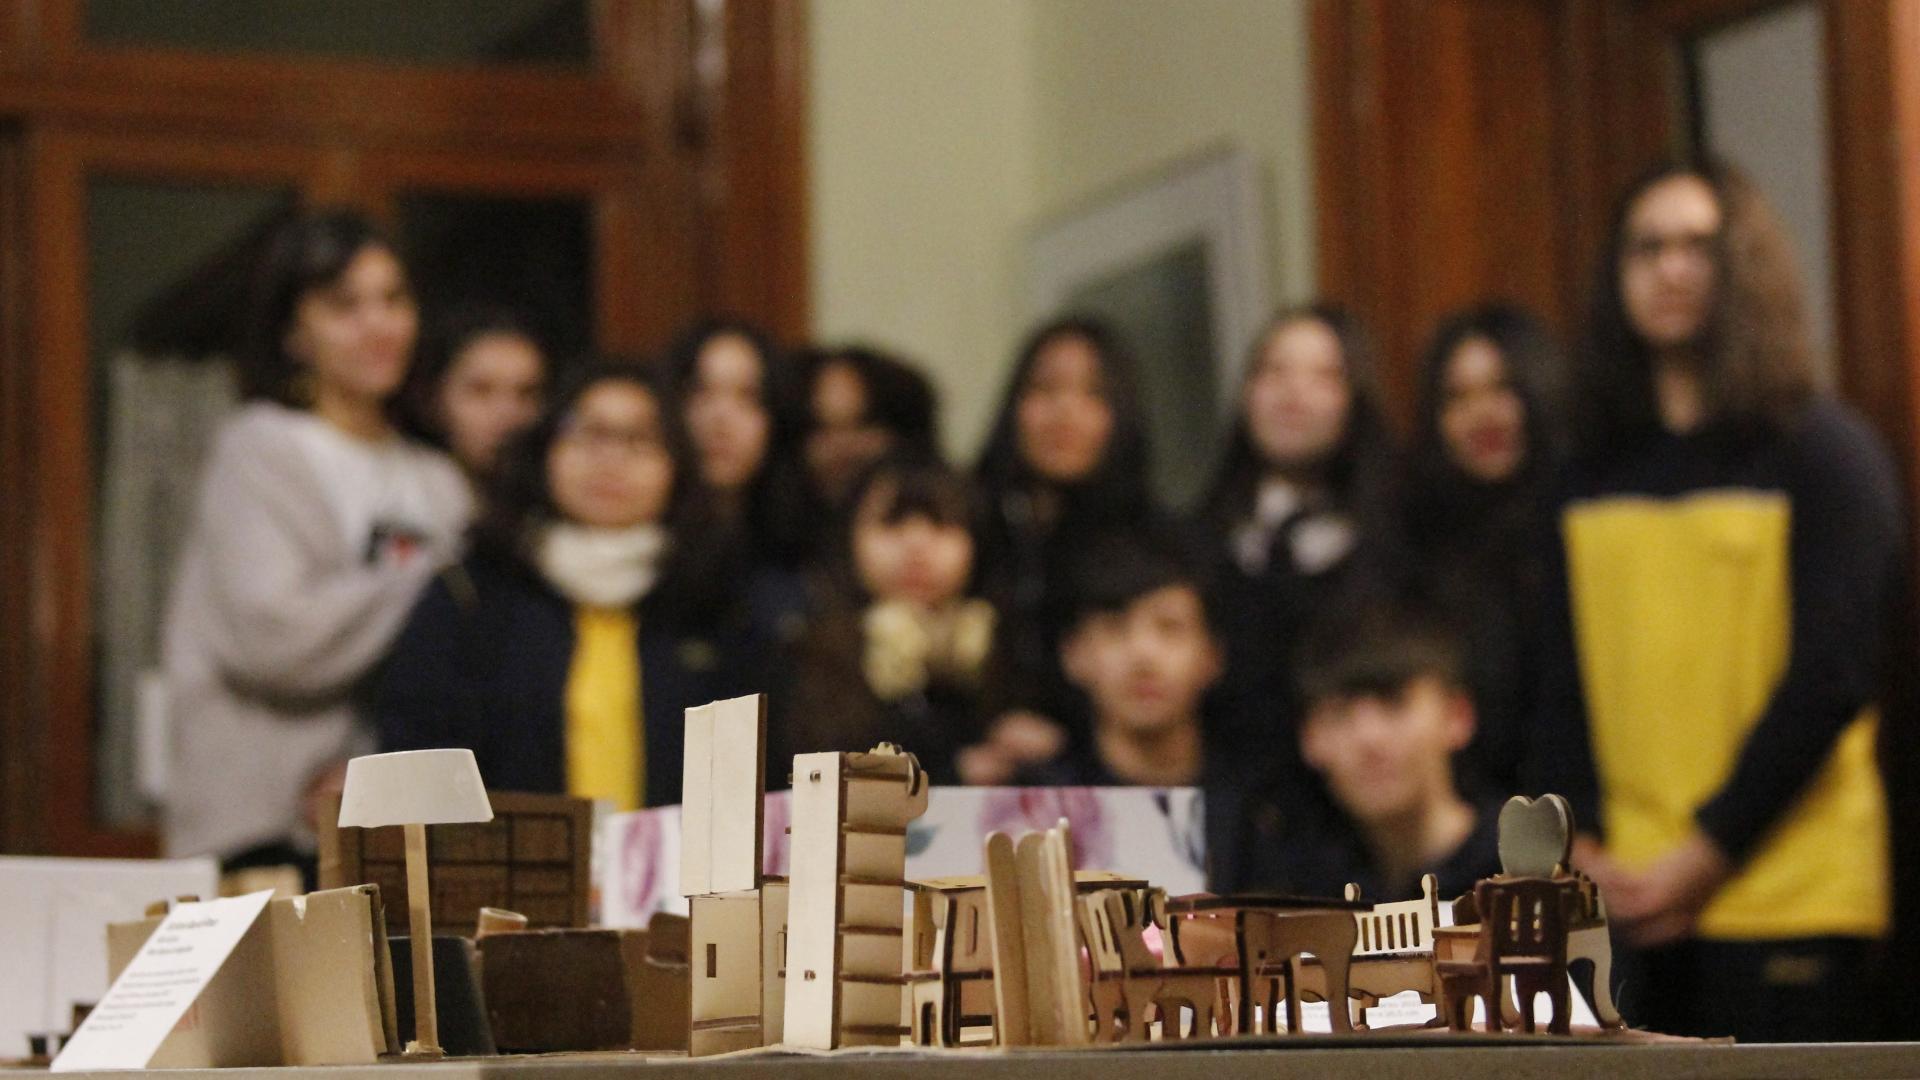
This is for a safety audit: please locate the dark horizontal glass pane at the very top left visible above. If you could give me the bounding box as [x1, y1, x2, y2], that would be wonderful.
[86, 0, 593, 67]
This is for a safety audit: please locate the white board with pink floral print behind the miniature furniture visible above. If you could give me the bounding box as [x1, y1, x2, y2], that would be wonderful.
[593, 788, 1206, 926]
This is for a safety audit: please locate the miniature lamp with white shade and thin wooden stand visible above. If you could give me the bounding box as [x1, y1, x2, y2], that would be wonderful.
[340, 749, 493, 1057]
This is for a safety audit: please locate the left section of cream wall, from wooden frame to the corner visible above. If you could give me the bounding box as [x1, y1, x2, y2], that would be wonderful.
[808, 0, 1033, 454]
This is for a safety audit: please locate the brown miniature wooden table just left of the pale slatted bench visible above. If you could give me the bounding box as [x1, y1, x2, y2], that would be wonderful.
[1167, 896, 1365, 1034]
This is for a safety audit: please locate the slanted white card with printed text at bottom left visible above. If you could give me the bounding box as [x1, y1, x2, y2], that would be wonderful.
[54, 890, 273, 1072]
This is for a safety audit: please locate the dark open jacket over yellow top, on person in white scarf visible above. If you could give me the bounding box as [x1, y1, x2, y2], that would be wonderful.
[374, 541, 764, 805]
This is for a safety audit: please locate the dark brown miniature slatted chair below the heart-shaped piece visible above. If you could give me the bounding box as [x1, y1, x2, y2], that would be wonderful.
[1434, 876, 1578, 1036]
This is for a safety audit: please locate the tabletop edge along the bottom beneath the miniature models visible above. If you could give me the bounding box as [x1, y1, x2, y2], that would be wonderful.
[22, 1034, 1920, 1080]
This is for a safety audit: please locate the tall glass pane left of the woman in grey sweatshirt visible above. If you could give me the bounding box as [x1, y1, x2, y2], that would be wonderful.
[86, 177, 296, 828]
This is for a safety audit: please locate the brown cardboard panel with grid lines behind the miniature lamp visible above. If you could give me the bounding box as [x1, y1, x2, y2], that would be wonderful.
[319, 792, 593, 930]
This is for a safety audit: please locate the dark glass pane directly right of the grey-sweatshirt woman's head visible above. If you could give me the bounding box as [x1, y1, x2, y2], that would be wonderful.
[397, 192, 593, 357]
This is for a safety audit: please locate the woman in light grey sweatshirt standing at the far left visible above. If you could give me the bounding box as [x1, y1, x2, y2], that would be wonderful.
[161, 211, 472, 867]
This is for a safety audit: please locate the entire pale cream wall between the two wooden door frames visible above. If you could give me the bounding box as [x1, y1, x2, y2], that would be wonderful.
[808, 0, 1313, 457]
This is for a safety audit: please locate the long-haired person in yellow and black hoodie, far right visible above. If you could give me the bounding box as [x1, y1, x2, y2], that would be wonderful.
[1534, 163, 1903, 1042]
